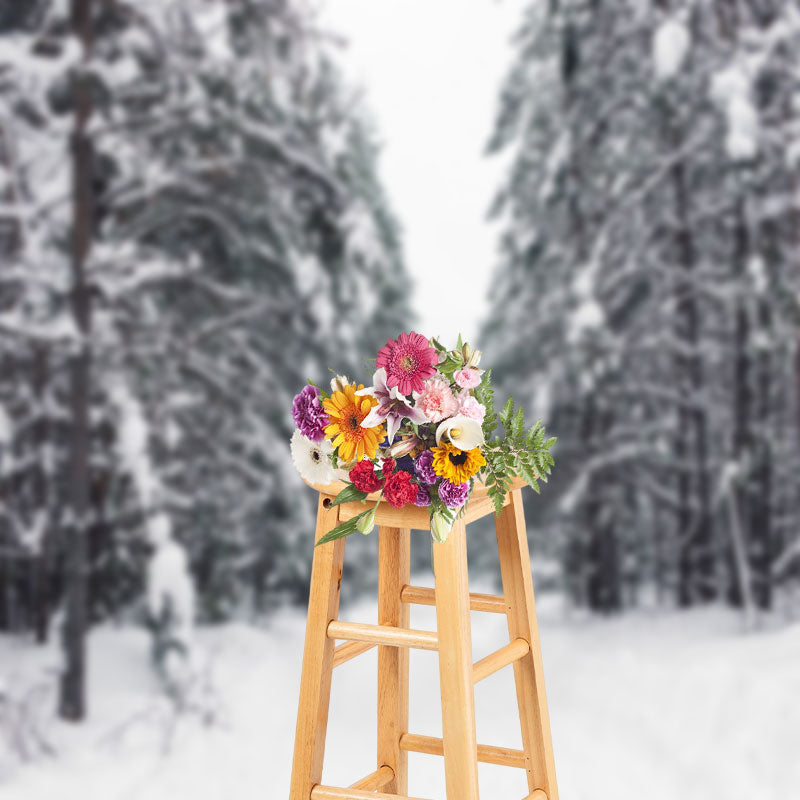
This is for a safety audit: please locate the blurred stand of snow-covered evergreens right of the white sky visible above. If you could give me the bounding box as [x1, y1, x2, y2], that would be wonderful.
[485, 0, 798, 610]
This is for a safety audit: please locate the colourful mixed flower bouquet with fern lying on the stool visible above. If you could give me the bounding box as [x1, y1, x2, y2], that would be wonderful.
[291, 331, 556, 544]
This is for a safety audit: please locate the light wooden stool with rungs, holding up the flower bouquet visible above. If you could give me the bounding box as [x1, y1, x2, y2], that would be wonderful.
[289, 480, 558, 800]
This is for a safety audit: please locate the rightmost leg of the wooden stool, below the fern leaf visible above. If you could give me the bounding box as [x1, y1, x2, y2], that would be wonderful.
[495, 489, 558, 800]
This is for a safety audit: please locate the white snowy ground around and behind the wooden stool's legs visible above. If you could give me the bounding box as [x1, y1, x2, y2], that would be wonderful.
[0, 587, 800, 800]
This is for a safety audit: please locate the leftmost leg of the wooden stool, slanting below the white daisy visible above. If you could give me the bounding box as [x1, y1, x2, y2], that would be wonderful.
[289, 495, 344, 800]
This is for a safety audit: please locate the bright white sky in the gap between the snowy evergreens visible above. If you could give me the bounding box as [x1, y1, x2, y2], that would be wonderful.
[321, 0, 525, 346]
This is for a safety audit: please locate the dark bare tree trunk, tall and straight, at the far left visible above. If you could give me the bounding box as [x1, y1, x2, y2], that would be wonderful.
[59, 0, 93, 721]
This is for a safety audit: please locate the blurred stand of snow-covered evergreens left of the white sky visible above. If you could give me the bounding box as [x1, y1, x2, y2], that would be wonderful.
[0, 0, 409, 688]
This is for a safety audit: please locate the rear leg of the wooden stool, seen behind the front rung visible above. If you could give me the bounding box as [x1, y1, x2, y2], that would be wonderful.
[378, 527, 411, 795]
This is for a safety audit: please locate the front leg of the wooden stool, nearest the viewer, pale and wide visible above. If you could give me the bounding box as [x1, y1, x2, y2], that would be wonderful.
[433, 520, 478, 800]
